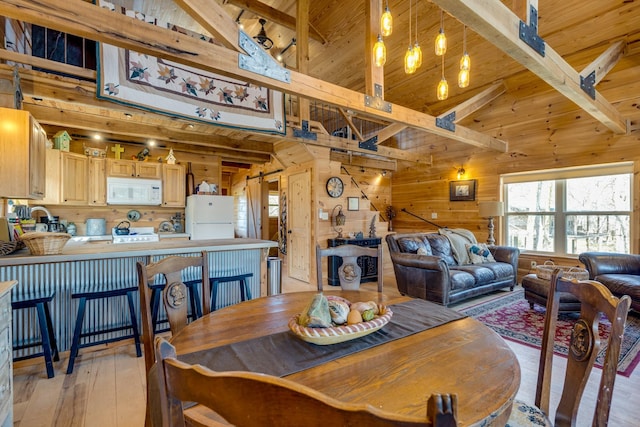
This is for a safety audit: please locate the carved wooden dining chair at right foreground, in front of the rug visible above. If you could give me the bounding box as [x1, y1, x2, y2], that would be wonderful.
[508, 269, 631, 427]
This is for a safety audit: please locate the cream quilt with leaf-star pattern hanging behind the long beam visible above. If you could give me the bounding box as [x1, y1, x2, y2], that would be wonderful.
[97, 0, 286, 134]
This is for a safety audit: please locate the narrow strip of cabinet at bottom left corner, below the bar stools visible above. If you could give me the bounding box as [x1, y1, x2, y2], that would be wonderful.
[0, 280, 17, 427]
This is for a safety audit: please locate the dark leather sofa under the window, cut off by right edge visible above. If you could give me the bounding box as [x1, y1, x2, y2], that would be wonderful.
[578, 252, 640, 312]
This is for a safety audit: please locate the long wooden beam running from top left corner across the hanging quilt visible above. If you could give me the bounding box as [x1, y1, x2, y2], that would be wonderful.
[0, 0, 507, 153]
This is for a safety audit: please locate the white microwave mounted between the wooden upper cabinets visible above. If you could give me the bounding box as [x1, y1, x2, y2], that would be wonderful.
[107, 177, 162, 206]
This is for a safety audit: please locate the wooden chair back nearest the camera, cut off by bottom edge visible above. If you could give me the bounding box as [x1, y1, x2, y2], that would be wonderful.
[154, 337, 457, 427]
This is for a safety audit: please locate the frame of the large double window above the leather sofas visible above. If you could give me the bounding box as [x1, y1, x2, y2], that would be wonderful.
[500, 162, 634, 257]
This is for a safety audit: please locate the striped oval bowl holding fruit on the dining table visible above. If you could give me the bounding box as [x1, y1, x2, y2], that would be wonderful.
[289, 297, 393, 345]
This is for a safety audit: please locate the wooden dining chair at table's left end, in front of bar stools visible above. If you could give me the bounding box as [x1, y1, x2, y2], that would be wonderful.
[137, 251, 211, 426]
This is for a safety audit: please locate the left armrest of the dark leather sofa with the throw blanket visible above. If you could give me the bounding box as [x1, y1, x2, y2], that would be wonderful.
[390, 252, 451, 305]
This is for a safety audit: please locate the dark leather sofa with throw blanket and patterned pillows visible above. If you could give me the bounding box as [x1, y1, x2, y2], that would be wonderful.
[385, 233, 520, 306]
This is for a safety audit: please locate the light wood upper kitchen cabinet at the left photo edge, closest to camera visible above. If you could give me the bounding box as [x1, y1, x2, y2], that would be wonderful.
[0, 108, 47, 200]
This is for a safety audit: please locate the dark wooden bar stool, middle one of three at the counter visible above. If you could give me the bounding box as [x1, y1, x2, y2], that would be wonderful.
[67, 286, 142, 374]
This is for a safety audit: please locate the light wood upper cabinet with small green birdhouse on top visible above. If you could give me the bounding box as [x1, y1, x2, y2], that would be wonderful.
[42, 150, 89, 206]
